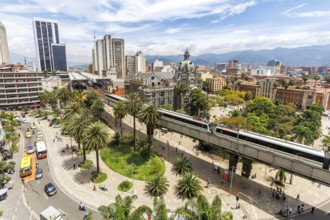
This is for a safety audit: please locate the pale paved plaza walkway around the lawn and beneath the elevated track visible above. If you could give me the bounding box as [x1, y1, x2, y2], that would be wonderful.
[29, 106, 330, 219]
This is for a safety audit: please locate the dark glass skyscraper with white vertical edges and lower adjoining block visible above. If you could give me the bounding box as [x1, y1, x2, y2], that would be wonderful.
[33, 18, 67, 72]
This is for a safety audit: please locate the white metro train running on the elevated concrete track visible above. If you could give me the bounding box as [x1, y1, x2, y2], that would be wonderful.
[106, 94, 330, 169]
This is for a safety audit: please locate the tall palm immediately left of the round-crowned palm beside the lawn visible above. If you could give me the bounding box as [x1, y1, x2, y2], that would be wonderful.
[67, 111, 93, 162]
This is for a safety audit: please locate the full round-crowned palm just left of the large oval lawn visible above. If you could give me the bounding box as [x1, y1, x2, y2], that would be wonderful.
[83, 121, 109, 175]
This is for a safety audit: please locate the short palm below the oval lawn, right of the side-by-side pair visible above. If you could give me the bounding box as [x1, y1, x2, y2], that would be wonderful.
[175, 173, 202, 200]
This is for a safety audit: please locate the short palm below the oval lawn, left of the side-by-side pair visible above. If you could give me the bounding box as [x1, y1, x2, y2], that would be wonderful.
[144, 175, 169, 197]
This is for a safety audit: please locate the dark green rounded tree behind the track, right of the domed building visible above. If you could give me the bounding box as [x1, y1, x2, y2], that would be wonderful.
[189, 89, 209, 115]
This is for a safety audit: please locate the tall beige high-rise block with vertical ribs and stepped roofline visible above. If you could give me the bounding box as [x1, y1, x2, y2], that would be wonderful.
[92, 35, 126, 79]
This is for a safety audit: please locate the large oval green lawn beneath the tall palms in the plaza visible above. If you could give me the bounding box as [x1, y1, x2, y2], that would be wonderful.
[101, 145, 165, 180]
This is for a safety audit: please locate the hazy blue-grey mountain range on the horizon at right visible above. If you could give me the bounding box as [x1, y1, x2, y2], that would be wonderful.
[146, 44, 330, 66]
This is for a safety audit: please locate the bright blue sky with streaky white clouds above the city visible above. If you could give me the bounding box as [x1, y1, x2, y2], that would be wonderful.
[0, 0, 330, 64]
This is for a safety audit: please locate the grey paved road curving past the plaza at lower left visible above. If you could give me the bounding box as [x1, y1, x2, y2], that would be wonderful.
[22, 121, 100, 220]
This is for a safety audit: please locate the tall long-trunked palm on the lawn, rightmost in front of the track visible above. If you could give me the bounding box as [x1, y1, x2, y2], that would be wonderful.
[138, 103, 160, 160]
